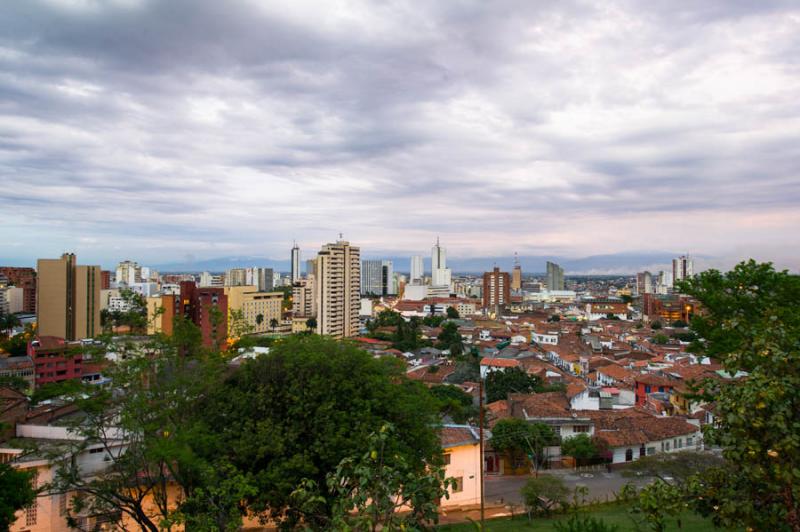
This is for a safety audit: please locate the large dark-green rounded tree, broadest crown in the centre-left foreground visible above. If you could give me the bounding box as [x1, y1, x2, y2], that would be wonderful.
[196, 335, 441, 529]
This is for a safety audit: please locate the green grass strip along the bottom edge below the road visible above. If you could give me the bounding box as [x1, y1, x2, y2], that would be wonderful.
[439, 504, 720, 532]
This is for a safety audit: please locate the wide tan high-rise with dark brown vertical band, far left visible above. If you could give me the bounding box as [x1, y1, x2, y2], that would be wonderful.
[36, 253, 101, 340]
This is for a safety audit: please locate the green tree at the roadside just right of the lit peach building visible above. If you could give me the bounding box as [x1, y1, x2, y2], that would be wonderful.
[490, 418, 558, 472]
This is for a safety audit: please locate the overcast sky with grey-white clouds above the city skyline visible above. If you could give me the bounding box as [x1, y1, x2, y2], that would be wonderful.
[0, 0, 800, 269]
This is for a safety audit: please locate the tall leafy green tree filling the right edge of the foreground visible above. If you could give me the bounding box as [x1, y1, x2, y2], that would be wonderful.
[678, 260, 800, 532]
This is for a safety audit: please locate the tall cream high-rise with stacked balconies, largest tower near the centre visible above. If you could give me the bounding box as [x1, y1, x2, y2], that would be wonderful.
[314, 240, 361, 338]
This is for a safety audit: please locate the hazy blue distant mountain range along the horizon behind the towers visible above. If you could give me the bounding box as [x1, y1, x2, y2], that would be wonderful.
[153, 252, 680, 275]
